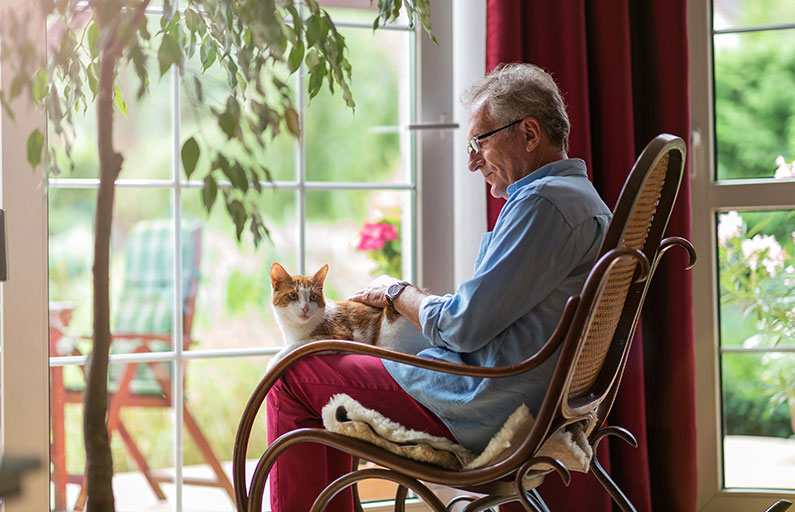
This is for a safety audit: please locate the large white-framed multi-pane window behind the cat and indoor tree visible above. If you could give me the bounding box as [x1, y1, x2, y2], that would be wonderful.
[3, 0, 460, 510]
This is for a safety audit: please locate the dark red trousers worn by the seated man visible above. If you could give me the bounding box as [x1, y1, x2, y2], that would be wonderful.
[267, 354, 522, 512]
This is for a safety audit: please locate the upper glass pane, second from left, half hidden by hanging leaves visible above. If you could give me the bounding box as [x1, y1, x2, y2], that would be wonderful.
[180, 46, 297, 181]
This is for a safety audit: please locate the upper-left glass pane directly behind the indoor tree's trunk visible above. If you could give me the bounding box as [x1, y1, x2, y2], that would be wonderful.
[49, 16, 173, 179]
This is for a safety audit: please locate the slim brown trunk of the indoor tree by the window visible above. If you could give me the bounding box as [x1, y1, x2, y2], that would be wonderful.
[83, 45, 122, 512]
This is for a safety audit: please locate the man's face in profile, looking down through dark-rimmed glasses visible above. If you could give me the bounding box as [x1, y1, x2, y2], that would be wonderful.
[467, 100, 527, 197]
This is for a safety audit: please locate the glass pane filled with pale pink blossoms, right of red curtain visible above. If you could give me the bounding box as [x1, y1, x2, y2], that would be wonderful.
[717, 210, 795, 348]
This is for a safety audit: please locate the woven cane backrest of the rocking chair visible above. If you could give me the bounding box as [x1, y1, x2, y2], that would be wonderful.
[564, 134, 685, 422]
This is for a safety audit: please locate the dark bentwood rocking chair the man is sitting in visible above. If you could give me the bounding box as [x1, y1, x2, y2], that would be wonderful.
[233, 135, 695, 512]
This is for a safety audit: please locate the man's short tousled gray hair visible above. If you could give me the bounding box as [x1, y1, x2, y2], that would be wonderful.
[461, 63, 570, 152]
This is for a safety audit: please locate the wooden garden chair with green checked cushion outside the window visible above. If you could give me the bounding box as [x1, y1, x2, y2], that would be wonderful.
[51, 220, 233, 510]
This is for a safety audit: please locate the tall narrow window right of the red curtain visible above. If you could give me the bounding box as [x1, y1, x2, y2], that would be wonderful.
[690, 0, 795, 510]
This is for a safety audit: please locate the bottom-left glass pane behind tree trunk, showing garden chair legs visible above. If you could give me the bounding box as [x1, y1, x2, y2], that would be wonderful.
[50, 363, 174, 511]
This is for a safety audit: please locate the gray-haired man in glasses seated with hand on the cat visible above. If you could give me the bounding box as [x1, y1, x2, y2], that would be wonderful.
[268, 64, 610, 511]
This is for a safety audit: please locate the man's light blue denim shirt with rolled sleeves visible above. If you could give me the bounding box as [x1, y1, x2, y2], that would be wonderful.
[384, 159, 611, 453]
